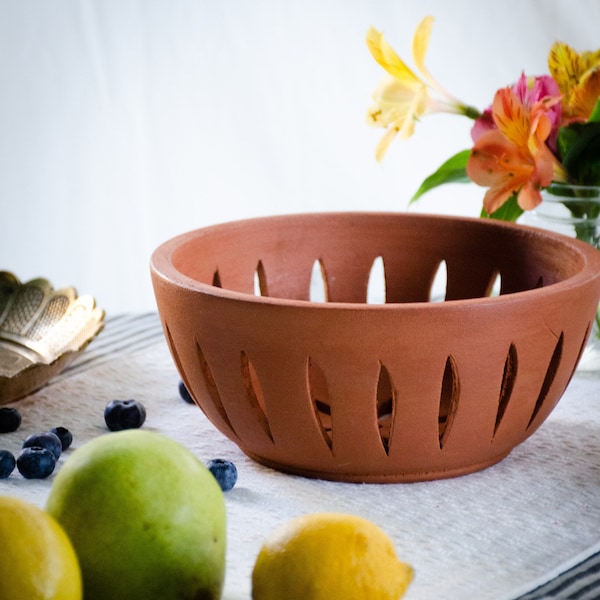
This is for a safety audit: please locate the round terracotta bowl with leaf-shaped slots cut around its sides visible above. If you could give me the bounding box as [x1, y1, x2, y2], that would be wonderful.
[151, 213, 600, 482]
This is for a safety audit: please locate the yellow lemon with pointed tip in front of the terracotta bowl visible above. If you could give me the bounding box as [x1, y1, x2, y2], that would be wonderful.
[252, 513, 413, 600]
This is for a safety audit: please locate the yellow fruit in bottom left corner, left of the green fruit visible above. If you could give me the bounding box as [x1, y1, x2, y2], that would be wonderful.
[0, 496, 82, 600]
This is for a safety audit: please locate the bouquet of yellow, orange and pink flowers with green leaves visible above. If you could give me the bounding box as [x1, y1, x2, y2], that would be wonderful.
[366, 16, 600, 366]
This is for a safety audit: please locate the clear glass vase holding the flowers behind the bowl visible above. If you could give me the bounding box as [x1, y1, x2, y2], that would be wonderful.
[522, 183, 600, 376]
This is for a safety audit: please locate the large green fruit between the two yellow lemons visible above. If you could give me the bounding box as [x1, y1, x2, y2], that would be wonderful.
[46, 429, 226, 600]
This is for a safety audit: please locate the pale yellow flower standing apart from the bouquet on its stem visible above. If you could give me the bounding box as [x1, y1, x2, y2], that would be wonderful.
[366, 16, 479, 160]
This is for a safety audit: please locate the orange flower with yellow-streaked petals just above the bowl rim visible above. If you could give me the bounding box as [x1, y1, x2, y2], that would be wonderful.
[467, 88, 561, 214]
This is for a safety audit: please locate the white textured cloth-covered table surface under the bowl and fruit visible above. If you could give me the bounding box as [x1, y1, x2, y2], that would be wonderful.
[0, 313, 600, 600]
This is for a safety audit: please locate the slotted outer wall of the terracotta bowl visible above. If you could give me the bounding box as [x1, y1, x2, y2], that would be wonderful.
[152, 213, 600, 481]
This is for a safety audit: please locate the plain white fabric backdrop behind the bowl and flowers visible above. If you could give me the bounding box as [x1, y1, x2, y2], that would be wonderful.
[0, 0, 600, 312]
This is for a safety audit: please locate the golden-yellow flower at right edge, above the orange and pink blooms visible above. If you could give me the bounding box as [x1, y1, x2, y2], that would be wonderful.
[548, 42, 600, 121]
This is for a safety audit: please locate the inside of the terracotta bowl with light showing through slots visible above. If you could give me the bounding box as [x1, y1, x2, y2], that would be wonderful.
[170, 213, 584, 303]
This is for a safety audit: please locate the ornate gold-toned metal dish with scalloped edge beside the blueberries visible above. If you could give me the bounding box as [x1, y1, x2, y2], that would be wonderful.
[0, 271, 104, 405]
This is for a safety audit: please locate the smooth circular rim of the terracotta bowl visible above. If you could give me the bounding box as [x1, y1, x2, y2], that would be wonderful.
[150, 211, 600, 311]
